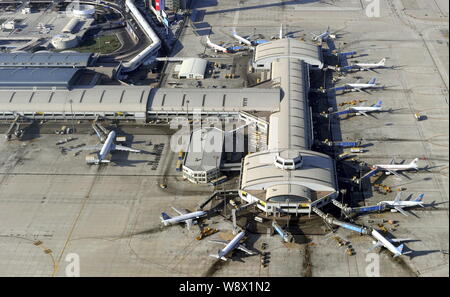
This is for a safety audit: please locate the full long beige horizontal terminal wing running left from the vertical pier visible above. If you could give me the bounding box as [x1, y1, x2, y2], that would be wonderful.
[0, 86, 280, 121]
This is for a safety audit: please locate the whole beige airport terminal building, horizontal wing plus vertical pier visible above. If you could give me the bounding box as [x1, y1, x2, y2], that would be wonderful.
[0, 39, 338, 214]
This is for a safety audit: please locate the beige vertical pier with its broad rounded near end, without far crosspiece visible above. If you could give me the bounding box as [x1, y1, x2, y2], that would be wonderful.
[240, 53, 337, 214]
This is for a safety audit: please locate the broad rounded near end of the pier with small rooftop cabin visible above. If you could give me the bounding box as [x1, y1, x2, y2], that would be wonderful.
[241, 150, 337, 213]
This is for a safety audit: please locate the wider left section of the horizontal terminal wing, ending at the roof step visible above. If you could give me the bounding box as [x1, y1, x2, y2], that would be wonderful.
[0, 86, 150, 121]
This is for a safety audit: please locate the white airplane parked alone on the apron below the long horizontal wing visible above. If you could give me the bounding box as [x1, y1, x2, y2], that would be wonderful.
[75, 124, 142, 165]
